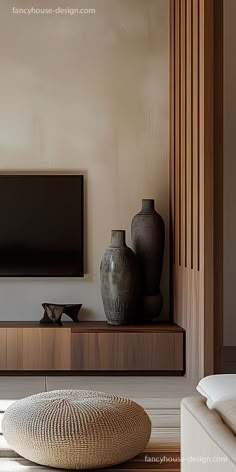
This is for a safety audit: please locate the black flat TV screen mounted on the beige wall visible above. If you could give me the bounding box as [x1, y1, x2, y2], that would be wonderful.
[0, 175, 84, 277]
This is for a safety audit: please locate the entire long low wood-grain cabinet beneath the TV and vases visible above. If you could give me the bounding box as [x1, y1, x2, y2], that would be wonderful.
[0, 321, 185, 375]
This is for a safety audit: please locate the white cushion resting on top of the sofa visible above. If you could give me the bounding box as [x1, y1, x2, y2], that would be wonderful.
[197, 374, 236, 408]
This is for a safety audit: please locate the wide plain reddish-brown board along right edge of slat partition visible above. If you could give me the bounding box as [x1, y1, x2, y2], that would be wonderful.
[199, 0, 214, 375]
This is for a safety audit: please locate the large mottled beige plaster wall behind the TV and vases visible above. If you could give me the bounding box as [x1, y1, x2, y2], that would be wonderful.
[0, 0, 169, 320]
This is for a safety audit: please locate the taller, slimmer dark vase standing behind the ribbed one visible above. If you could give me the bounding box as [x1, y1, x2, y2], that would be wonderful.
[131, 199, 165, 321]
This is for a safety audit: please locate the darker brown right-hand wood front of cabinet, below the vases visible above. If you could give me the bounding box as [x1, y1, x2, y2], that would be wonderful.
[71, 332, 183, 371]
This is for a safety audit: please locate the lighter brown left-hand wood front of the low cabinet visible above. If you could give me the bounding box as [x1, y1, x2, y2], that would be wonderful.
[7, 327, 71, 370]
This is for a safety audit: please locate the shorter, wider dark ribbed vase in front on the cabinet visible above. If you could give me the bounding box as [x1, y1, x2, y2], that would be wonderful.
[100, 231, 139, 325]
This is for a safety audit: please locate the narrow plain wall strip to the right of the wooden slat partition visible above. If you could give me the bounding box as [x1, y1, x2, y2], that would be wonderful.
[224, 0, 236, 346]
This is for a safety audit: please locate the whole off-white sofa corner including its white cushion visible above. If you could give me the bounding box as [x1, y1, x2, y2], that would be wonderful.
[181, 375, 236, 472]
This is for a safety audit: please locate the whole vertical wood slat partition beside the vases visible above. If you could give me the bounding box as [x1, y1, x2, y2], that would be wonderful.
[170, 0, 223, 382]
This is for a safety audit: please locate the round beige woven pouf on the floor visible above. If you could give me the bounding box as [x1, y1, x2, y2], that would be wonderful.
[2, 390, 151, 470]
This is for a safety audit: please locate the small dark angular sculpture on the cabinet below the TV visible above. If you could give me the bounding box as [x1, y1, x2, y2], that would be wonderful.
[40, 303, 82, 326]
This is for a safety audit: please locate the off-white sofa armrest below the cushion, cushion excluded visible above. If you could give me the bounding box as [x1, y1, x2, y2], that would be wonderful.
[181, 397, 236, 472]
